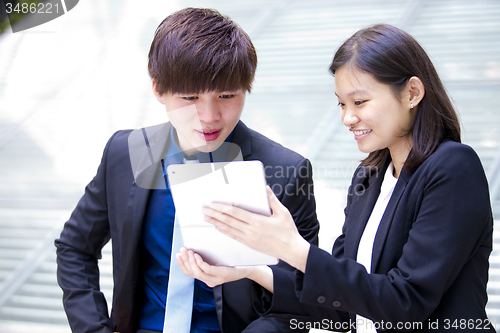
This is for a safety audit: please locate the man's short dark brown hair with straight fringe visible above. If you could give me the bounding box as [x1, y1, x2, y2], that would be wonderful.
[148, 8, 257, 95]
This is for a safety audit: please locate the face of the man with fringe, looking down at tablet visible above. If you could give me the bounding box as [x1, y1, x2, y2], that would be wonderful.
[153, 82, 246, 155]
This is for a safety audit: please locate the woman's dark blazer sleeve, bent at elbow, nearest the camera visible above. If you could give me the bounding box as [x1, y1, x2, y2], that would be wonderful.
[296, 145, 492, 323]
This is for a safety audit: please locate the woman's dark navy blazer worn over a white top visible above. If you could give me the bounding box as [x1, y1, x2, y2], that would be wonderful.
[271, 141, 494, 332]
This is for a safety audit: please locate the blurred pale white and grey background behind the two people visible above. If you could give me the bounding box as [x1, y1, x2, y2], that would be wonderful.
[0, 0, 500, 333]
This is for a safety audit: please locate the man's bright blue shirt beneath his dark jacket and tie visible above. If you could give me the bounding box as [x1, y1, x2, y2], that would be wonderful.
[139, 128, 233, 333]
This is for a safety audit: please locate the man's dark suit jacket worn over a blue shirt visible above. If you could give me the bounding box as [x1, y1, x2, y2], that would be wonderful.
[55, 121, 319, 333]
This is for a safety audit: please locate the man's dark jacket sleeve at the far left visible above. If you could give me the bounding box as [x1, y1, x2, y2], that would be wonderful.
[55, 132, 120, 333]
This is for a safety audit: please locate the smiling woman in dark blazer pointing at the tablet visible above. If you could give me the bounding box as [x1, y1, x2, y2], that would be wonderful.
[178, 25, 495, 332]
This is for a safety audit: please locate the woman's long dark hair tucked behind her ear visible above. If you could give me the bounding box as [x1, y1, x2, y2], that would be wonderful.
[330, 24, 461, 172]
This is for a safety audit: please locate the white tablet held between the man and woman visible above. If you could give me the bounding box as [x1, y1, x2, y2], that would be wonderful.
[167, 161, 278, 266]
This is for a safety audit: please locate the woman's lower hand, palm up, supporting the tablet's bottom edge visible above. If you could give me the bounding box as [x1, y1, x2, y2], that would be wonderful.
[175, 248, 273, 292]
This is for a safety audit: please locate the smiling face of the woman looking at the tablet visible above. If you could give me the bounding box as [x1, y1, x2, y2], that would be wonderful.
[335, 66, 415, 162]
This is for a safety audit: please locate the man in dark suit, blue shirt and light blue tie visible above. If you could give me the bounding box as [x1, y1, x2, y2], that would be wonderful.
[55, 8, 319, 333]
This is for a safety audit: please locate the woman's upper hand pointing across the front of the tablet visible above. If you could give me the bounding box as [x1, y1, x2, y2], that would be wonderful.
[203, 186, 309, 272]
